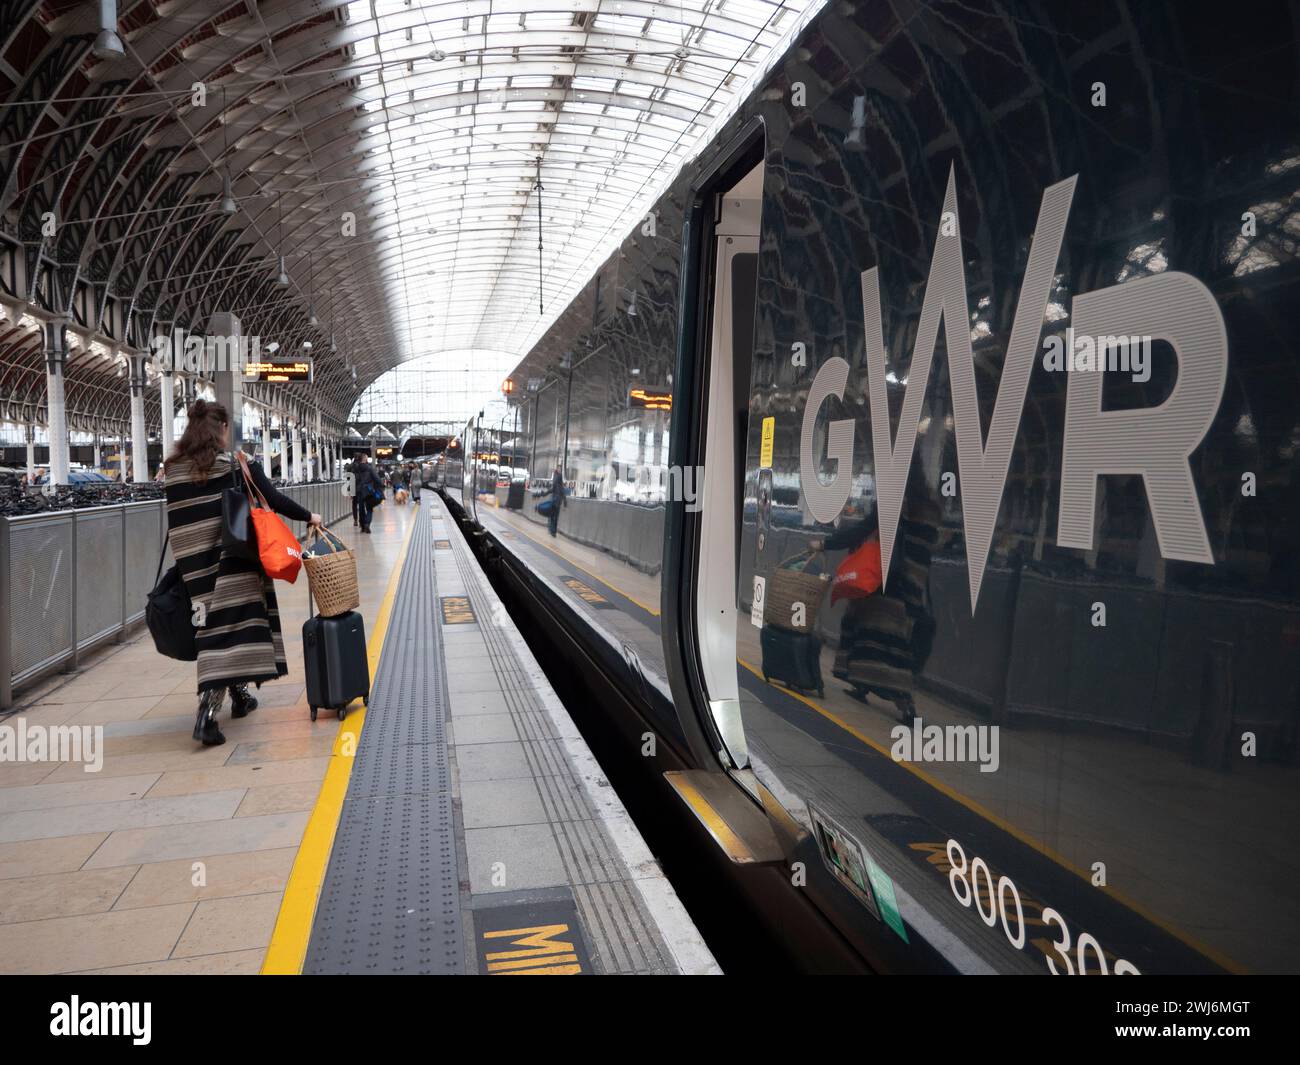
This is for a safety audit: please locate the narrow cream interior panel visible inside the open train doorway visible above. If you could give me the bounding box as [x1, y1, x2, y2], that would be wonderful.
[696, 163, 763, 769]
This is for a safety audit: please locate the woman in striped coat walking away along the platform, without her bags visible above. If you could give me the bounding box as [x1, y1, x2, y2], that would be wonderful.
[165, 399, 321, 746]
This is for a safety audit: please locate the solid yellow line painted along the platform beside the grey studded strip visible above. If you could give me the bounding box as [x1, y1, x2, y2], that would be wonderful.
[261, 511, 410, 977]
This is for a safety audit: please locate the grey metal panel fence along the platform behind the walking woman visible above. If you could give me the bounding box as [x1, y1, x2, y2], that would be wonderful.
[0, 481, 352, 710]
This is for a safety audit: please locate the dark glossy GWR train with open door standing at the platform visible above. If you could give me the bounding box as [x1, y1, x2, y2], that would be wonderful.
[436, 0, 1300, 975]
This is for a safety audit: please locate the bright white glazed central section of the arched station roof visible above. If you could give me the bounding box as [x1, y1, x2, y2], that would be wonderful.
[350, 0, 819, 366]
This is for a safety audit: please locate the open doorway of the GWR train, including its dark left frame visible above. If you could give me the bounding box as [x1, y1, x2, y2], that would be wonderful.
[667, 143, 763, 783]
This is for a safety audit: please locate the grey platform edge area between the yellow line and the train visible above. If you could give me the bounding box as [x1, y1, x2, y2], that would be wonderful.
[286, 495, 716, 974]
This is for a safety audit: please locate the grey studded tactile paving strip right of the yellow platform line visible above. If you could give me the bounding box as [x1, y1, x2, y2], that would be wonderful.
[303, 511, 465, 974]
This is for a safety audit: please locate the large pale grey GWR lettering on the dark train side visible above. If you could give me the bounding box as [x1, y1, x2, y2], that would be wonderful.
[800, 169, 1227, 614]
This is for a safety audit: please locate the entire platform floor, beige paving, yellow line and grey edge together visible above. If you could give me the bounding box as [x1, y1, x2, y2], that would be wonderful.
[0, 493, 716, 974]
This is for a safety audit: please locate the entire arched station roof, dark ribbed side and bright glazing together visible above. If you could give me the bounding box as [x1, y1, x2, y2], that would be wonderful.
[0, 0, 820, 428]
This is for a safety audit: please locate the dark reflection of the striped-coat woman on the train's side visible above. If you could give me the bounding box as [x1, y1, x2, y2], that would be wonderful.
[810, 501, 939, 723]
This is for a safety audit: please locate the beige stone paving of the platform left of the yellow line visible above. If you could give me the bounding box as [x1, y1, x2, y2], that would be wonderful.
[0, 506, 412, 974]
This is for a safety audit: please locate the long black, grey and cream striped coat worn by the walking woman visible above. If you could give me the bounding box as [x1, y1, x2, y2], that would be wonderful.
[166, 455, 289, 692]
